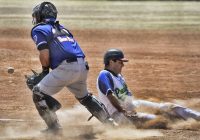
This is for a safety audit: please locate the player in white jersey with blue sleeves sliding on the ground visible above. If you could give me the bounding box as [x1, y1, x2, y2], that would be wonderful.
[97, 49, 200, 127]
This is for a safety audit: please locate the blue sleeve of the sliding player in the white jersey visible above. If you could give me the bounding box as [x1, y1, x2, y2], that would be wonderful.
[98, 71, 114, 95]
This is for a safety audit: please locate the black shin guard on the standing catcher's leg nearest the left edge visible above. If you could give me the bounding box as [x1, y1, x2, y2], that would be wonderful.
[33, 87, 61, 130]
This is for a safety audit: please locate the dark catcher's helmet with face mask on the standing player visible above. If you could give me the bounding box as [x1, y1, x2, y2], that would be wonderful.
[32, 2, 58, 24]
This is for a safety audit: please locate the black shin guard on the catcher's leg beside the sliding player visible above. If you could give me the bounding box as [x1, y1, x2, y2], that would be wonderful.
[78, 94, 117, 126]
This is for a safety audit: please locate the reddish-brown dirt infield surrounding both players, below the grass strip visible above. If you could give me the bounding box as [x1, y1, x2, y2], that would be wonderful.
[0, 28, 200, 140]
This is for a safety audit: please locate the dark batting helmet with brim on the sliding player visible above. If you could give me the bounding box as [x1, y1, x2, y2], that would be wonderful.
[104, 49, 128, 65]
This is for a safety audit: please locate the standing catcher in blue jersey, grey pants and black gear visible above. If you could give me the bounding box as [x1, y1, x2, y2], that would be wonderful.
[27, 2, 115, 132]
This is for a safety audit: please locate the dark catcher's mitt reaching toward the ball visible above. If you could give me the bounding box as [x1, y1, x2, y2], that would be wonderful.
[25, 70, 48, 90]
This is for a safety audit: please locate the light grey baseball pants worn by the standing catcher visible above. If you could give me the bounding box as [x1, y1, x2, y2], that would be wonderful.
[38, 58, 88, 98]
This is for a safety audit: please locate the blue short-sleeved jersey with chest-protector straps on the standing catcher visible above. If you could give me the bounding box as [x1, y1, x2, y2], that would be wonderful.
[31, 23, 85, 69]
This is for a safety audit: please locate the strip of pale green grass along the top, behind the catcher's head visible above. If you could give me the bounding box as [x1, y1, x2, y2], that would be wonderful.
[0, 0, 200, 30]
